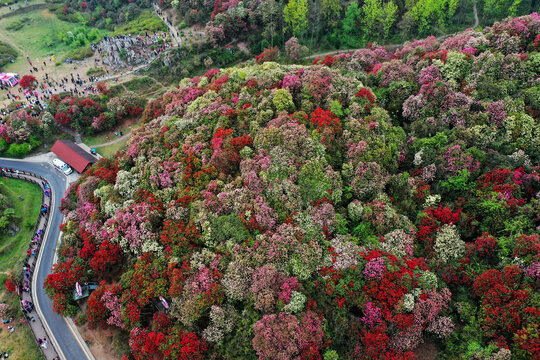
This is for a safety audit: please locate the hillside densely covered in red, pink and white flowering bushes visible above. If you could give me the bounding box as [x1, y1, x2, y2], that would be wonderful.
[45, 14, 540, 360]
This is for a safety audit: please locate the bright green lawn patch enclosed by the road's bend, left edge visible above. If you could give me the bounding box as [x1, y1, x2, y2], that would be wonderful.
[0, 178, 41, 270]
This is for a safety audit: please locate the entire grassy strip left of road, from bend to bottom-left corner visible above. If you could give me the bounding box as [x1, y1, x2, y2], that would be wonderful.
[0, 178, 44, 360]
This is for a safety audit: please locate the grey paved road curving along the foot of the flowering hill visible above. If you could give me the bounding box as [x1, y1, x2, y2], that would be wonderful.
[0, 158, 93, 360]
